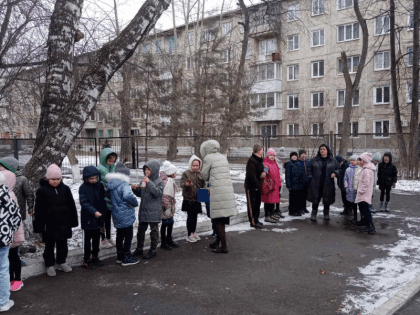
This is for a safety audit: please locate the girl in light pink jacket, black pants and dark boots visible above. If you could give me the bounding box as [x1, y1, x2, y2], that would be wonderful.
[356, 152, 376, 234]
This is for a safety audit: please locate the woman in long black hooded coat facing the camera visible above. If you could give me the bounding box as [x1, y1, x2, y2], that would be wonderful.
[307, 144, 340, 221]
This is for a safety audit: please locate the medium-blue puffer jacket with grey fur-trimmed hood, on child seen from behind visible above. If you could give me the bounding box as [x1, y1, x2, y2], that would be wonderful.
[106, 173, 139, 229]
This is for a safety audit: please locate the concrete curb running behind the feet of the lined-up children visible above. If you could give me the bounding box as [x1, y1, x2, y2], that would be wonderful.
[22, 202, 288, 280]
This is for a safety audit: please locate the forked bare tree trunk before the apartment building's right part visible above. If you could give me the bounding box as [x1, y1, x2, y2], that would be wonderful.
[338, 0, 369, 157]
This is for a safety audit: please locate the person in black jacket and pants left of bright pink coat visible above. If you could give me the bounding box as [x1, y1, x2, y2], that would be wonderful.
[244, 144, 267, 228]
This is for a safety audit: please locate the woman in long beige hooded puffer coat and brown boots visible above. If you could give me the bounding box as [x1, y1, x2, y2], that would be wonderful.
[200, 140, 237, 254]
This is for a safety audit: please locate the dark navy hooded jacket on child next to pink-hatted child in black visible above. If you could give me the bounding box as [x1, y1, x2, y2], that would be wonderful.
[79, 166, 107, 230]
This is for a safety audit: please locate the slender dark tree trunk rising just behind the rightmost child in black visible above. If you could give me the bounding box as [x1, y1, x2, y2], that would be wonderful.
[389, 0, 409, 167]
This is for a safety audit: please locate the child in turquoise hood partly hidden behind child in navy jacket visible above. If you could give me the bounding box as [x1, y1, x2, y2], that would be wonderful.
[98, 148, 118, 248]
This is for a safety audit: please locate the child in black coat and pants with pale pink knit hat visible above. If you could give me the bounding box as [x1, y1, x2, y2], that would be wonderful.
[33, 164, 79, 277]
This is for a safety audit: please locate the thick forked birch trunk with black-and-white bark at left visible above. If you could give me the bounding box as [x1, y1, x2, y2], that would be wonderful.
[24, 0, 170, 185]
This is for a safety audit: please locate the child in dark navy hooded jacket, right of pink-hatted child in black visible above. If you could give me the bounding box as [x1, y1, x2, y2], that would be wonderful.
[79, 165, 107, 270]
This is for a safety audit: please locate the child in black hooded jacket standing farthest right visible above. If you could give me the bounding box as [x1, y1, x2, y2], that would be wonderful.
[378, 152, 398, 212]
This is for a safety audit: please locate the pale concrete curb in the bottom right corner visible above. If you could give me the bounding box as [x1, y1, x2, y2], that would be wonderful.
[369, 275, 420, 315]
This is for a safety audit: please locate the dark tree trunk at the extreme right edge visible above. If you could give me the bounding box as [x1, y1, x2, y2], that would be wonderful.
[410, 0, 420, 179]
